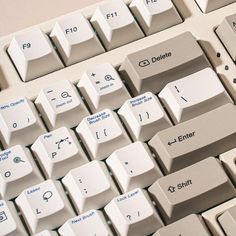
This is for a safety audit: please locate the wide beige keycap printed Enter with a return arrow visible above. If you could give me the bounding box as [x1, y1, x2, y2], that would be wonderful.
[149, 104, 236, 173]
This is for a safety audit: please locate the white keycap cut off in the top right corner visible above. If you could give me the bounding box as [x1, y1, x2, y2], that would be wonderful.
[196, 0, 235, 13]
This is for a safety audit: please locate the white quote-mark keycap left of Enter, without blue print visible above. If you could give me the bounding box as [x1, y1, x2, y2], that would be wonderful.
[106, 142, 162, 192]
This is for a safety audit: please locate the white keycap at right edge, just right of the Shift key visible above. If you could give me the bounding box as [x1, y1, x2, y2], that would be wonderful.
[219, 148, 236, 184]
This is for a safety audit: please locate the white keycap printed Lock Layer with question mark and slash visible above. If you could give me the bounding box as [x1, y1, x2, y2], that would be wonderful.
[104, 188, 163, 236]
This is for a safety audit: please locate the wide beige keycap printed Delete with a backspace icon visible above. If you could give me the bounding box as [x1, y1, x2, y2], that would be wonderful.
[119, 32, 210, 95]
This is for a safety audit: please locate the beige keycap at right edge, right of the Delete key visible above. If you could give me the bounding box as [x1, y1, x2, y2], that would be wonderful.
[216, 14, 236, 61]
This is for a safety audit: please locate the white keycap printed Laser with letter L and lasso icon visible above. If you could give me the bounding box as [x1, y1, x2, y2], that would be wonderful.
[16, 180, 75, 234]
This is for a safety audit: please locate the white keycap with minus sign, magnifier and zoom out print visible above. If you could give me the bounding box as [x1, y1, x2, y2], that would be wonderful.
[35, 80, 89, 130]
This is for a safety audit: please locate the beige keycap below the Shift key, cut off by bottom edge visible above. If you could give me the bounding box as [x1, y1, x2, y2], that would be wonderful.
[153, 214, 211, 236]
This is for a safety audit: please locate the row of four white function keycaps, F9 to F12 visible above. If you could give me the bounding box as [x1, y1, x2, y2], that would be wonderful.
[7, 0, 182, 82]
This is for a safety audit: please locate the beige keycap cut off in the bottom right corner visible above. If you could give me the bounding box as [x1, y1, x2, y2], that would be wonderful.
[218, 206, 236, 236]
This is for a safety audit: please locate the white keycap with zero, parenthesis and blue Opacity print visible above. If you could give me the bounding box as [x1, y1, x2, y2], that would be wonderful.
[0, 97, 46, 148]
